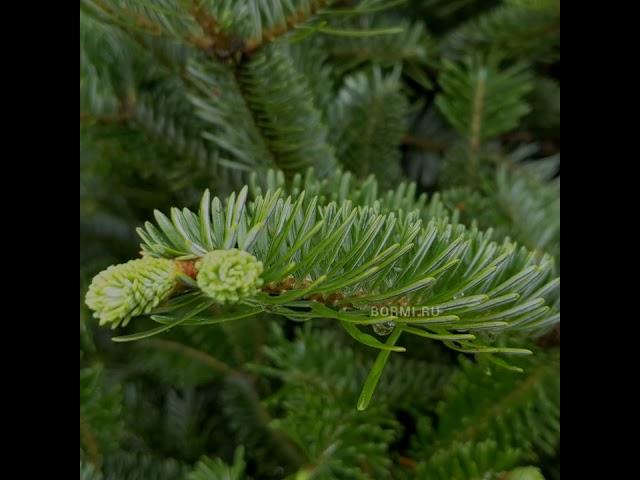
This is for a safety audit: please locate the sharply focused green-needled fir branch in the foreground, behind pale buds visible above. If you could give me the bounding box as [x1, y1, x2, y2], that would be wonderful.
[86, 187, 558, 408]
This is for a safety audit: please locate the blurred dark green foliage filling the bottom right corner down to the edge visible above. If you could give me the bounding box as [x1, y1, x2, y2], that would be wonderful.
[414, 351, 560, 478]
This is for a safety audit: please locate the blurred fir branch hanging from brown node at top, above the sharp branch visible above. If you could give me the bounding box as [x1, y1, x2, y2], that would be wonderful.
[188, 45, 335, 175]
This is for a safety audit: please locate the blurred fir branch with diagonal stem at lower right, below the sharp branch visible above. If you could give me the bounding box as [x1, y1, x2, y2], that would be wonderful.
[415, 349, 560, 467]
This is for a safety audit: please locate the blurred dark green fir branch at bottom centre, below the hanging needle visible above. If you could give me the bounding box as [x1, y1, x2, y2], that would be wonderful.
[258, 328, 440, 478]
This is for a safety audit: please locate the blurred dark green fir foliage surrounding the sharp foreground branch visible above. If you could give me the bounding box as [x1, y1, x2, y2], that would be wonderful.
[80, 0, 560, 480]
